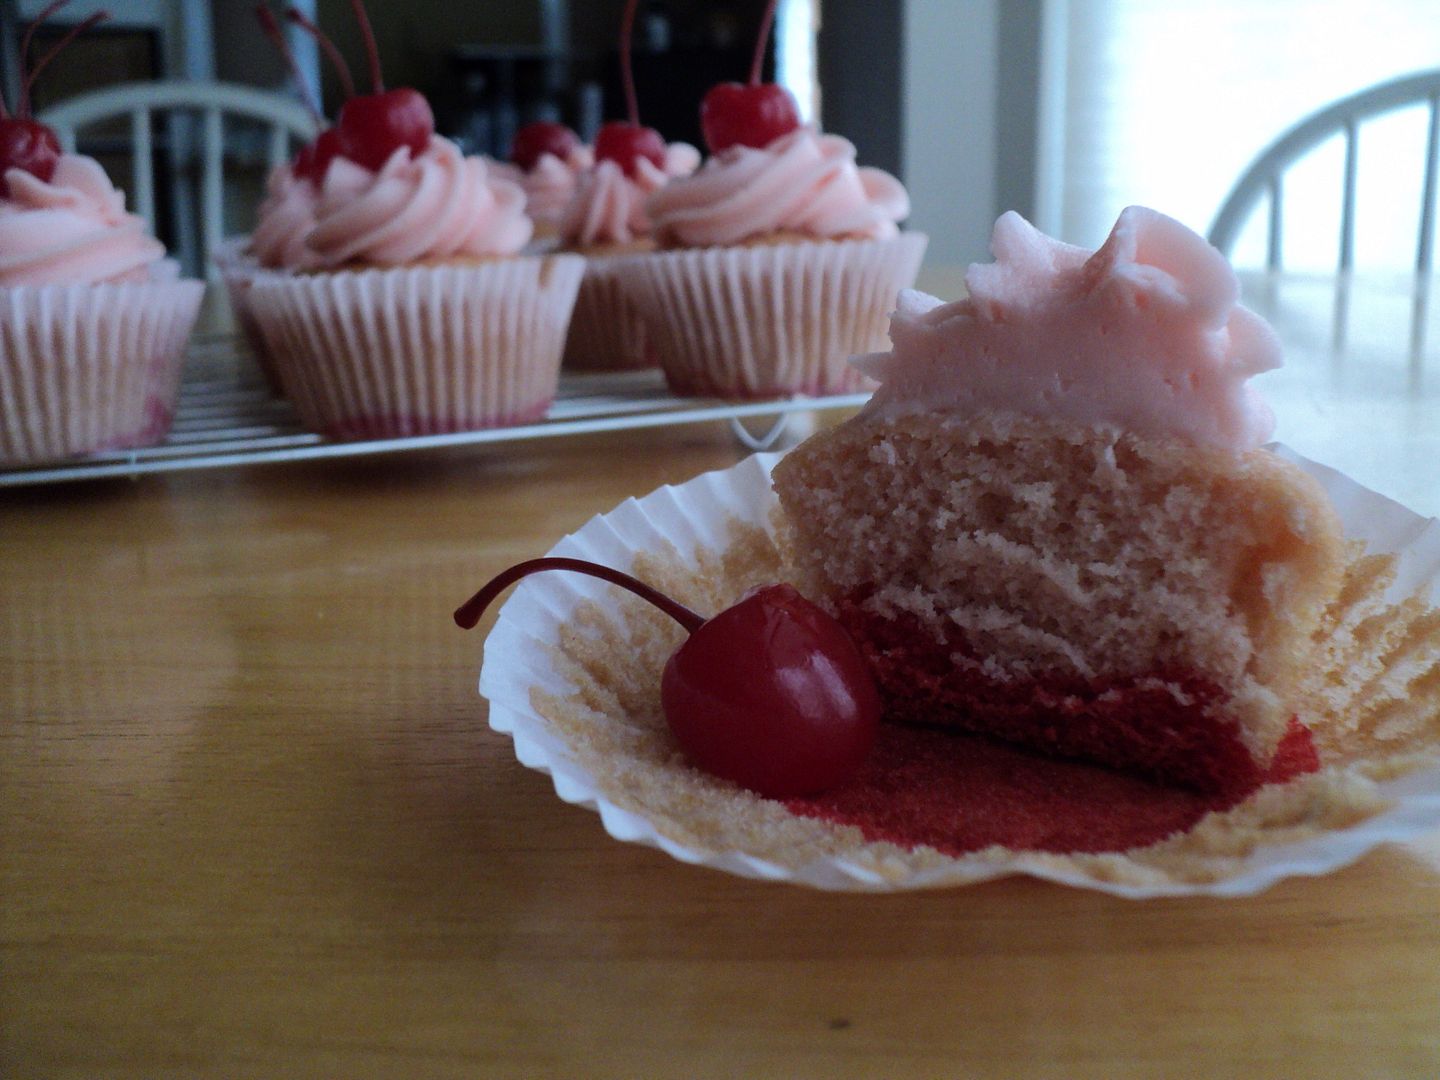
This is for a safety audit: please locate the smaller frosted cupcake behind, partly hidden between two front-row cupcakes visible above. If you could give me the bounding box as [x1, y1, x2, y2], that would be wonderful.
[560, 143, 700, 370]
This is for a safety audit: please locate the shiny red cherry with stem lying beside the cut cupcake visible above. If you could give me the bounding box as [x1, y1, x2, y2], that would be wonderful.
[455, 556, 880, 798]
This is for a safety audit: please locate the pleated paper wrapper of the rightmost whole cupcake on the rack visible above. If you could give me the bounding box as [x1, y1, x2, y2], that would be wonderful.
[621, 232, 926, 399]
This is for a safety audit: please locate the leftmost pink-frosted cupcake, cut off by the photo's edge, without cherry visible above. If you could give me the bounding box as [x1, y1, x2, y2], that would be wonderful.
[0, 154, 204, 465]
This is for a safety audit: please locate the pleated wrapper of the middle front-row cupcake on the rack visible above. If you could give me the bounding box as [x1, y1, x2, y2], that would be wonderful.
[249, 255, 585, 439]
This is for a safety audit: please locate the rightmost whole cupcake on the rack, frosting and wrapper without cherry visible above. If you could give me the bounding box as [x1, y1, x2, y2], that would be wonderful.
[624, 119, 926, 397]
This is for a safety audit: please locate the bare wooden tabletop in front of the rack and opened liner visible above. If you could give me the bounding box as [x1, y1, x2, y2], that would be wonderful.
[0, 426, 1440, 1079]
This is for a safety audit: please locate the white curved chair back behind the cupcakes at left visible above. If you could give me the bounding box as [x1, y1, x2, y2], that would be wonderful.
[40, 82, 315, 278]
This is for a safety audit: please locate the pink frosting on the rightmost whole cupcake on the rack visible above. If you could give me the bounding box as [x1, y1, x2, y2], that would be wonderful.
[647, 128, 910, 248]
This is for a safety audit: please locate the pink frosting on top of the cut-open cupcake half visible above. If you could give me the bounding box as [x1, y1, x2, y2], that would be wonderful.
[857, 206, 1280, 451]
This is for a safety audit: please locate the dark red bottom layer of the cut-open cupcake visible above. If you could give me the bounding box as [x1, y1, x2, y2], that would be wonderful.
[838, 602, 1264, 792]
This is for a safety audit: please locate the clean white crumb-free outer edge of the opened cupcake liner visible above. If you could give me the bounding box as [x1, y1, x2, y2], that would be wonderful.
[480, 448, 1440, 899]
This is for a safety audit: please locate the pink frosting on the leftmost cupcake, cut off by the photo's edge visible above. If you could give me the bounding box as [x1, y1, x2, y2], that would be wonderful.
[0, 154, 166, 285]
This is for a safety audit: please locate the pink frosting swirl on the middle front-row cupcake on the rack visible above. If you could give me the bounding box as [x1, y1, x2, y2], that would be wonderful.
[305, 135, 533, 266]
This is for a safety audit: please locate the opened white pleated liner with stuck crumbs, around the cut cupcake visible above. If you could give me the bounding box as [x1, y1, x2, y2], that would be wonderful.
[478, 448, 1440, 897]
